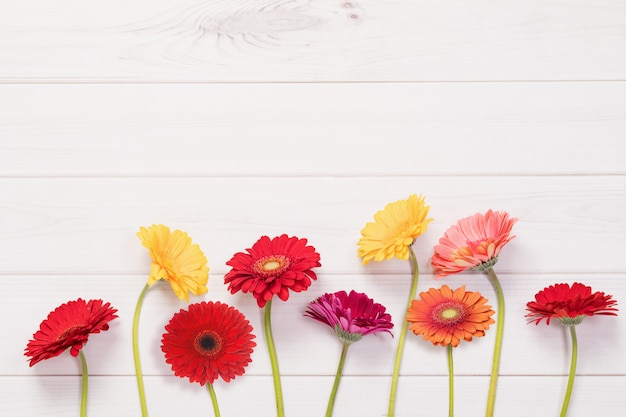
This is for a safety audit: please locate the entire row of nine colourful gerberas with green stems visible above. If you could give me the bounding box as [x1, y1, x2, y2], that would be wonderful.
[25, 194, 617, 417]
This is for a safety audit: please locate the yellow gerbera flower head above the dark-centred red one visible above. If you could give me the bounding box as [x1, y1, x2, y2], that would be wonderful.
[137, 224, 209, 302]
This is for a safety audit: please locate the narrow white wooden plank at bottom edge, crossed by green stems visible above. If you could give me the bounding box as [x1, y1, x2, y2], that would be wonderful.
[0, 376, 626, 417]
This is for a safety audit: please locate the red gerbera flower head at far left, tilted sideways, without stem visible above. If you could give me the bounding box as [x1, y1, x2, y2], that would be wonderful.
[24, 298, 117, 366]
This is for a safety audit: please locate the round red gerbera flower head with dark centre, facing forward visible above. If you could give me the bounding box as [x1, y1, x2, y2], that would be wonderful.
[161, 301, 256, 385]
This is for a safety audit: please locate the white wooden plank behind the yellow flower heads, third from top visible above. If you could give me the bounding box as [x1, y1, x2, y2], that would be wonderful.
[0, 176, 626, 275]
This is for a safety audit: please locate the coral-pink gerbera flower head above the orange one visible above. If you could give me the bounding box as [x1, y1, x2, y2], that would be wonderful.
[432, 210, 517, 278]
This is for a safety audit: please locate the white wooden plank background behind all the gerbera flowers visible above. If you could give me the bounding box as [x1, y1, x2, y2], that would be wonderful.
[0, 0, 626, 417]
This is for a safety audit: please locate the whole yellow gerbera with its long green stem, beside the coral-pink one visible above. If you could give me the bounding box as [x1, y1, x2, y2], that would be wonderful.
[357, 194, 433, 417]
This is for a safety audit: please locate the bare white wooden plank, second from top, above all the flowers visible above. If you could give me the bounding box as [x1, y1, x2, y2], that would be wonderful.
[0, 82, 626, 177]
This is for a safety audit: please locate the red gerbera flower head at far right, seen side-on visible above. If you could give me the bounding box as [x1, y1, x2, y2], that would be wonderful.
[526, 282, 618, 325]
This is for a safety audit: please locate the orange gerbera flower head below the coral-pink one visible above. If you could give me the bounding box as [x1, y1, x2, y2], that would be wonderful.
[407, 285, 495, 347]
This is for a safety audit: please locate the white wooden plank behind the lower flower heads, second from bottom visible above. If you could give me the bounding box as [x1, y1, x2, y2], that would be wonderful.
[6, 272, 626, 376]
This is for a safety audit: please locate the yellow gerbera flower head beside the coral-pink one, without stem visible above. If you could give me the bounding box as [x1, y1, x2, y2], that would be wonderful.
[357, 194, 433, 265]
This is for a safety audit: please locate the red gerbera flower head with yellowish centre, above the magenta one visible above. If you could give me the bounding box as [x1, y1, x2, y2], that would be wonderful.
[224, 235, 321, 307]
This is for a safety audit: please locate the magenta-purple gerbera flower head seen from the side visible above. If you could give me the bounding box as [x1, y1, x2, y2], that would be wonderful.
[304, 290, 393, 343]
